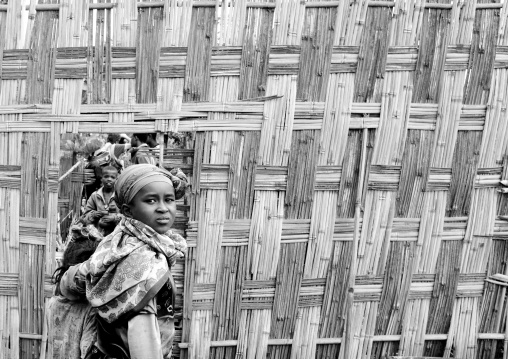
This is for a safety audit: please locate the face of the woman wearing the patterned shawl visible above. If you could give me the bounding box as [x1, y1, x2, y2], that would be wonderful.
[125, 182, 176, 234]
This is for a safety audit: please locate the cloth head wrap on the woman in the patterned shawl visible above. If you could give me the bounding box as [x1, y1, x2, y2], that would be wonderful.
[115, 164, 188, 208]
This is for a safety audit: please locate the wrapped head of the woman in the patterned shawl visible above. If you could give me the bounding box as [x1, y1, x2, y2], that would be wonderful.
[115, 164, 187, 234]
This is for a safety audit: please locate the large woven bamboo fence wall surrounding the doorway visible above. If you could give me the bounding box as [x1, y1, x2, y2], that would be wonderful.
[0, 0, 508, 358]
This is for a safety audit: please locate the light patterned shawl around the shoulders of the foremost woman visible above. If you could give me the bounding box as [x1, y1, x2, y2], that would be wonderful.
[86, 218, 187, 323]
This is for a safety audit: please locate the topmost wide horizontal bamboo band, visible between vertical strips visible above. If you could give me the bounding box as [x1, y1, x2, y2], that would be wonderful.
[3, 45, 507, 80]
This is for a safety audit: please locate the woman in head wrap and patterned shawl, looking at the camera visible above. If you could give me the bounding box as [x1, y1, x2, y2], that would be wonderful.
[64, 164, 188, 359]
